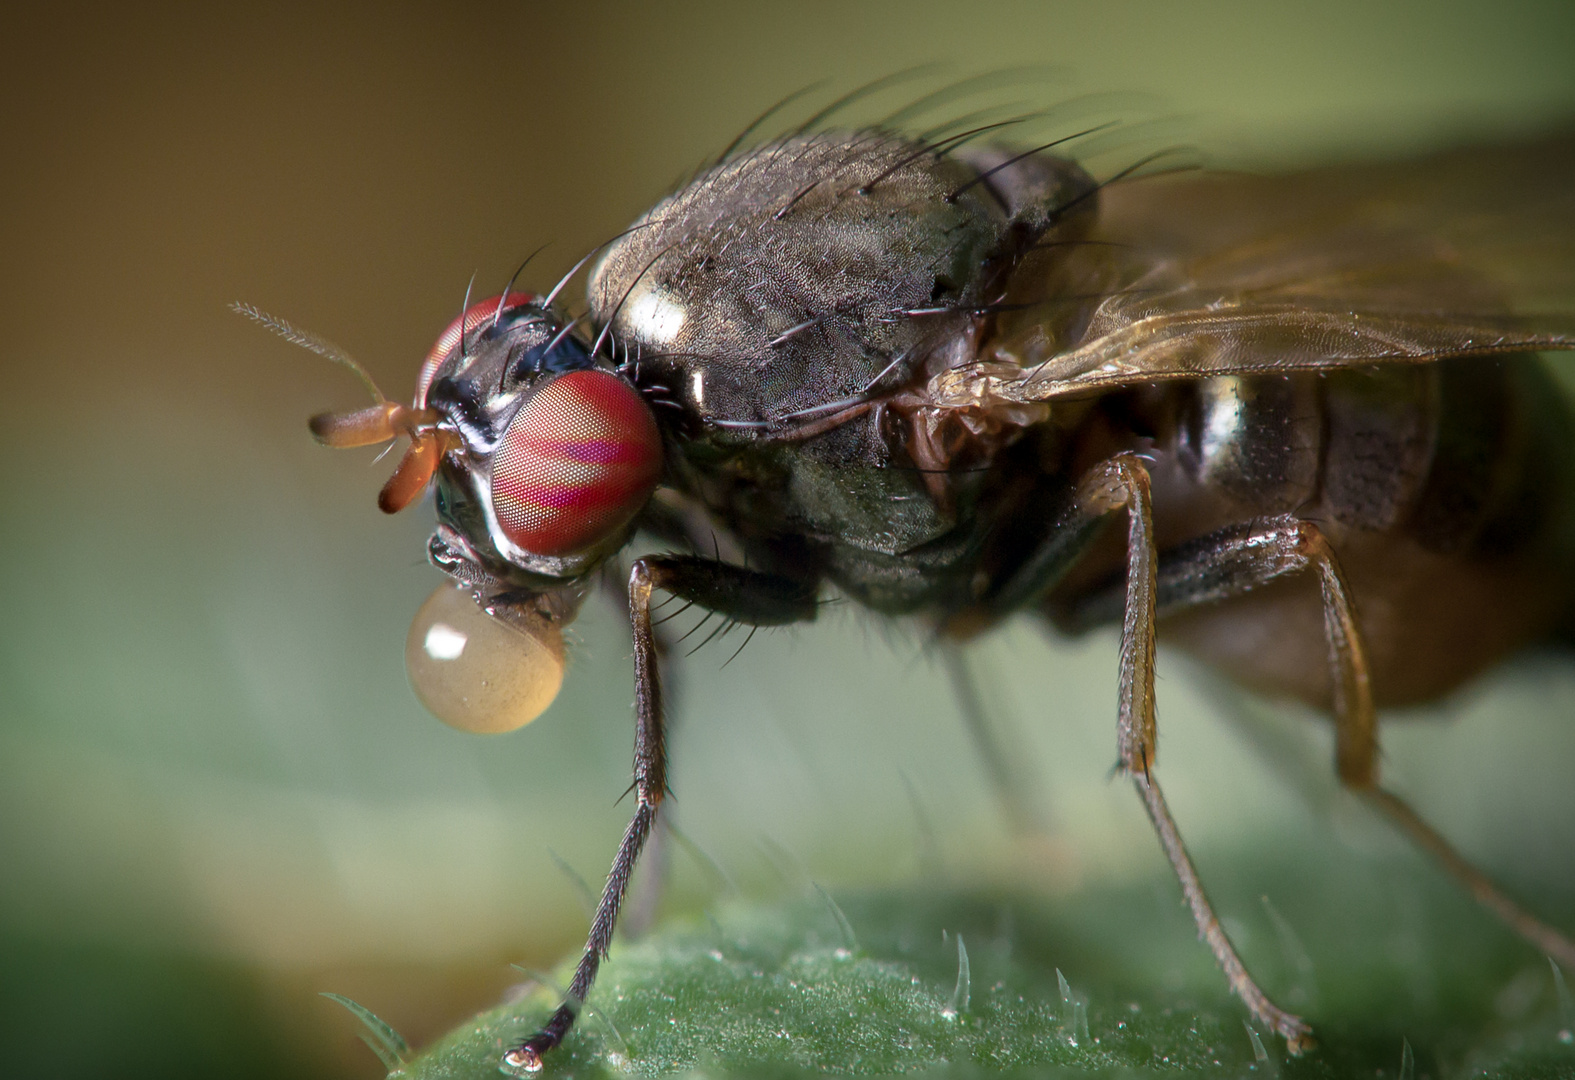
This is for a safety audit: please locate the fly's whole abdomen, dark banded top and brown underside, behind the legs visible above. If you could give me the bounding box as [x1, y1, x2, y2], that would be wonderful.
[1154, 356, 1575, 705]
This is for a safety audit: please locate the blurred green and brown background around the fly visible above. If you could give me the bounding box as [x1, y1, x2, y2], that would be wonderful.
[0, 0, 1575, 1077]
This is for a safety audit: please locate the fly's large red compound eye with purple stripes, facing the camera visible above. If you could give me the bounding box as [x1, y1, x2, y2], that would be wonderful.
[491, 368, 662, 556]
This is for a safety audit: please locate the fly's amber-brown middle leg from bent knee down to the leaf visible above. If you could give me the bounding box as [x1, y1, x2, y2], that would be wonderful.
[1068, 453, 1312, 1053]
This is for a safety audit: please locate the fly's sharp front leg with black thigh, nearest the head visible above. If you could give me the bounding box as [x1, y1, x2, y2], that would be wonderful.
[502, 556, 817, 1072]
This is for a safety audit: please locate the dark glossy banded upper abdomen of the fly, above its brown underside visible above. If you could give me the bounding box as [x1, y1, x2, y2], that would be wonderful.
[1170, 356, 1575, 562]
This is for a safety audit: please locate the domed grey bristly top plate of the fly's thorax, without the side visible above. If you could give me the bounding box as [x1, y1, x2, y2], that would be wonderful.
[589, 131, 1095, 441]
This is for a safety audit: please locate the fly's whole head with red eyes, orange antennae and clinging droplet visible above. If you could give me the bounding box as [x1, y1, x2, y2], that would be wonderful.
[291, 293, 662, 730]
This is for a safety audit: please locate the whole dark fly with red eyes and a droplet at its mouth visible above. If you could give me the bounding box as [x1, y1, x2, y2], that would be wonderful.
[239, 101, 1575, 1071]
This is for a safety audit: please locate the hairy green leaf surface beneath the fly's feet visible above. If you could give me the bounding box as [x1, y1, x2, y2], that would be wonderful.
[395, 867, 1575, 1080]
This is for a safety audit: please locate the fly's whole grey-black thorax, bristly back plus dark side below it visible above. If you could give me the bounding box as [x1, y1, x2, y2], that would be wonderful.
[589, 131, 1095, 609]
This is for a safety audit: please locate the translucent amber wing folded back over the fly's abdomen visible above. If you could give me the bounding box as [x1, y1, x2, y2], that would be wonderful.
[929, 137, 1575, 406]
